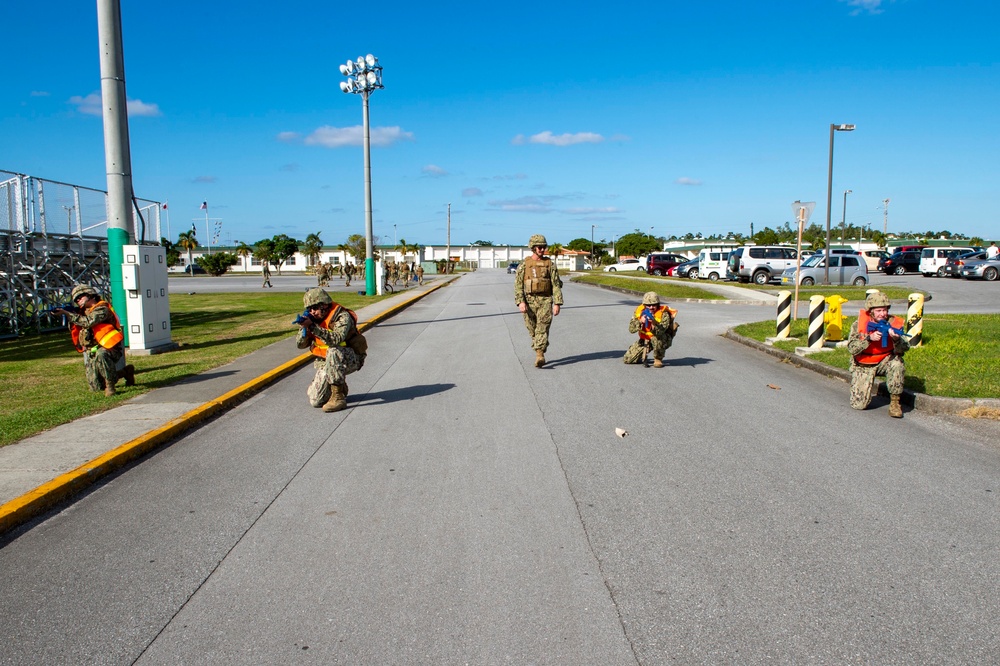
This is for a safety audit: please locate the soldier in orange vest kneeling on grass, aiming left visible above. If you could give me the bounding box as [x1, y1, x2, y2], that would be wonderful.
[53, 284, 135, 398]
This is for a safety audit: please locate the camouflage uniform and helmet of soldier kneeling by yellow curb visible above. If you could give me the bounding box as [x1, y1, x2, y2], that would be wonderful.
[295, 288, 368, 411]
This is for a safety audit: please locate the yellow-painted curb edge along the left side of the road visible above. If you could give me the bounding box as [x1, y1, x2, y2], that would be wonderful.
[0, 278, 455, 534]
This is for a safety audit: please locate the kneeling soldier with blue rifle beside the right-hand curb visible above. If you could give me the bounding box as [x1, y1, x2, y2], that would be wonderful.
[847, 292, 910, 419]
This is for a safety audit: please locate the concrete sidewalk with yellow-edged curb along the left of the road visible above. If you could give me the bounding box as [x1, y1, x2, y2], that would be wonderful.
[0, 276, 458, 534]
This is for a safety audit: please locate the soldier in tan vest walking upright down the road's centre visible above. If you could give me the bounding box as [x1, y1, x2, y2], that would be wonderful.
[514, 234, 562, 368]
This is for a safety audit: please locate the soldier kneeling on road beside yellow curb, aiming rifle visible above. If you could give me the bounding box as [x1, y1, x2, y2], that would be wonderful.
[294, 287, 368, 412]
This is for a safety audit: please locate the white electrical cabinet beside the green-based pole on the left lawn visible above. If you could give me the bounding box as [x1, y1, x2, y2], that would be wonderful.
[122, 245, 177, 354]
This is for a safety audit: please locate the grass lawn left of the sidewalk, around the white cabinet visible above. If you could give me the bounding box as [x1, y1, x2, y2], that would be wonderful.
[0, 292, 383, 446]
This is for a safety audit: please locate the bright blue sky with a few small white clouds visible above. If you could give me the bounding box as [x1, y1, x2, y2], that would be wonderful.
[0, 0, 1000, 245]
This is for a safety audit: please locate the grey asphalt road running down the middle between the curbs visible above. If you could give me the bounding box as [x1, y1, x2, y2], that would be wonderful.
[0, 270, 1000, 665]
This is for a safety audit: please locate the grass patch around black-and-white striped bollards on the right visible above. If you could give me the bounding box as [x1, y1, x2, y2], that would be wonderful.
[733, 314, 1000, 398]
